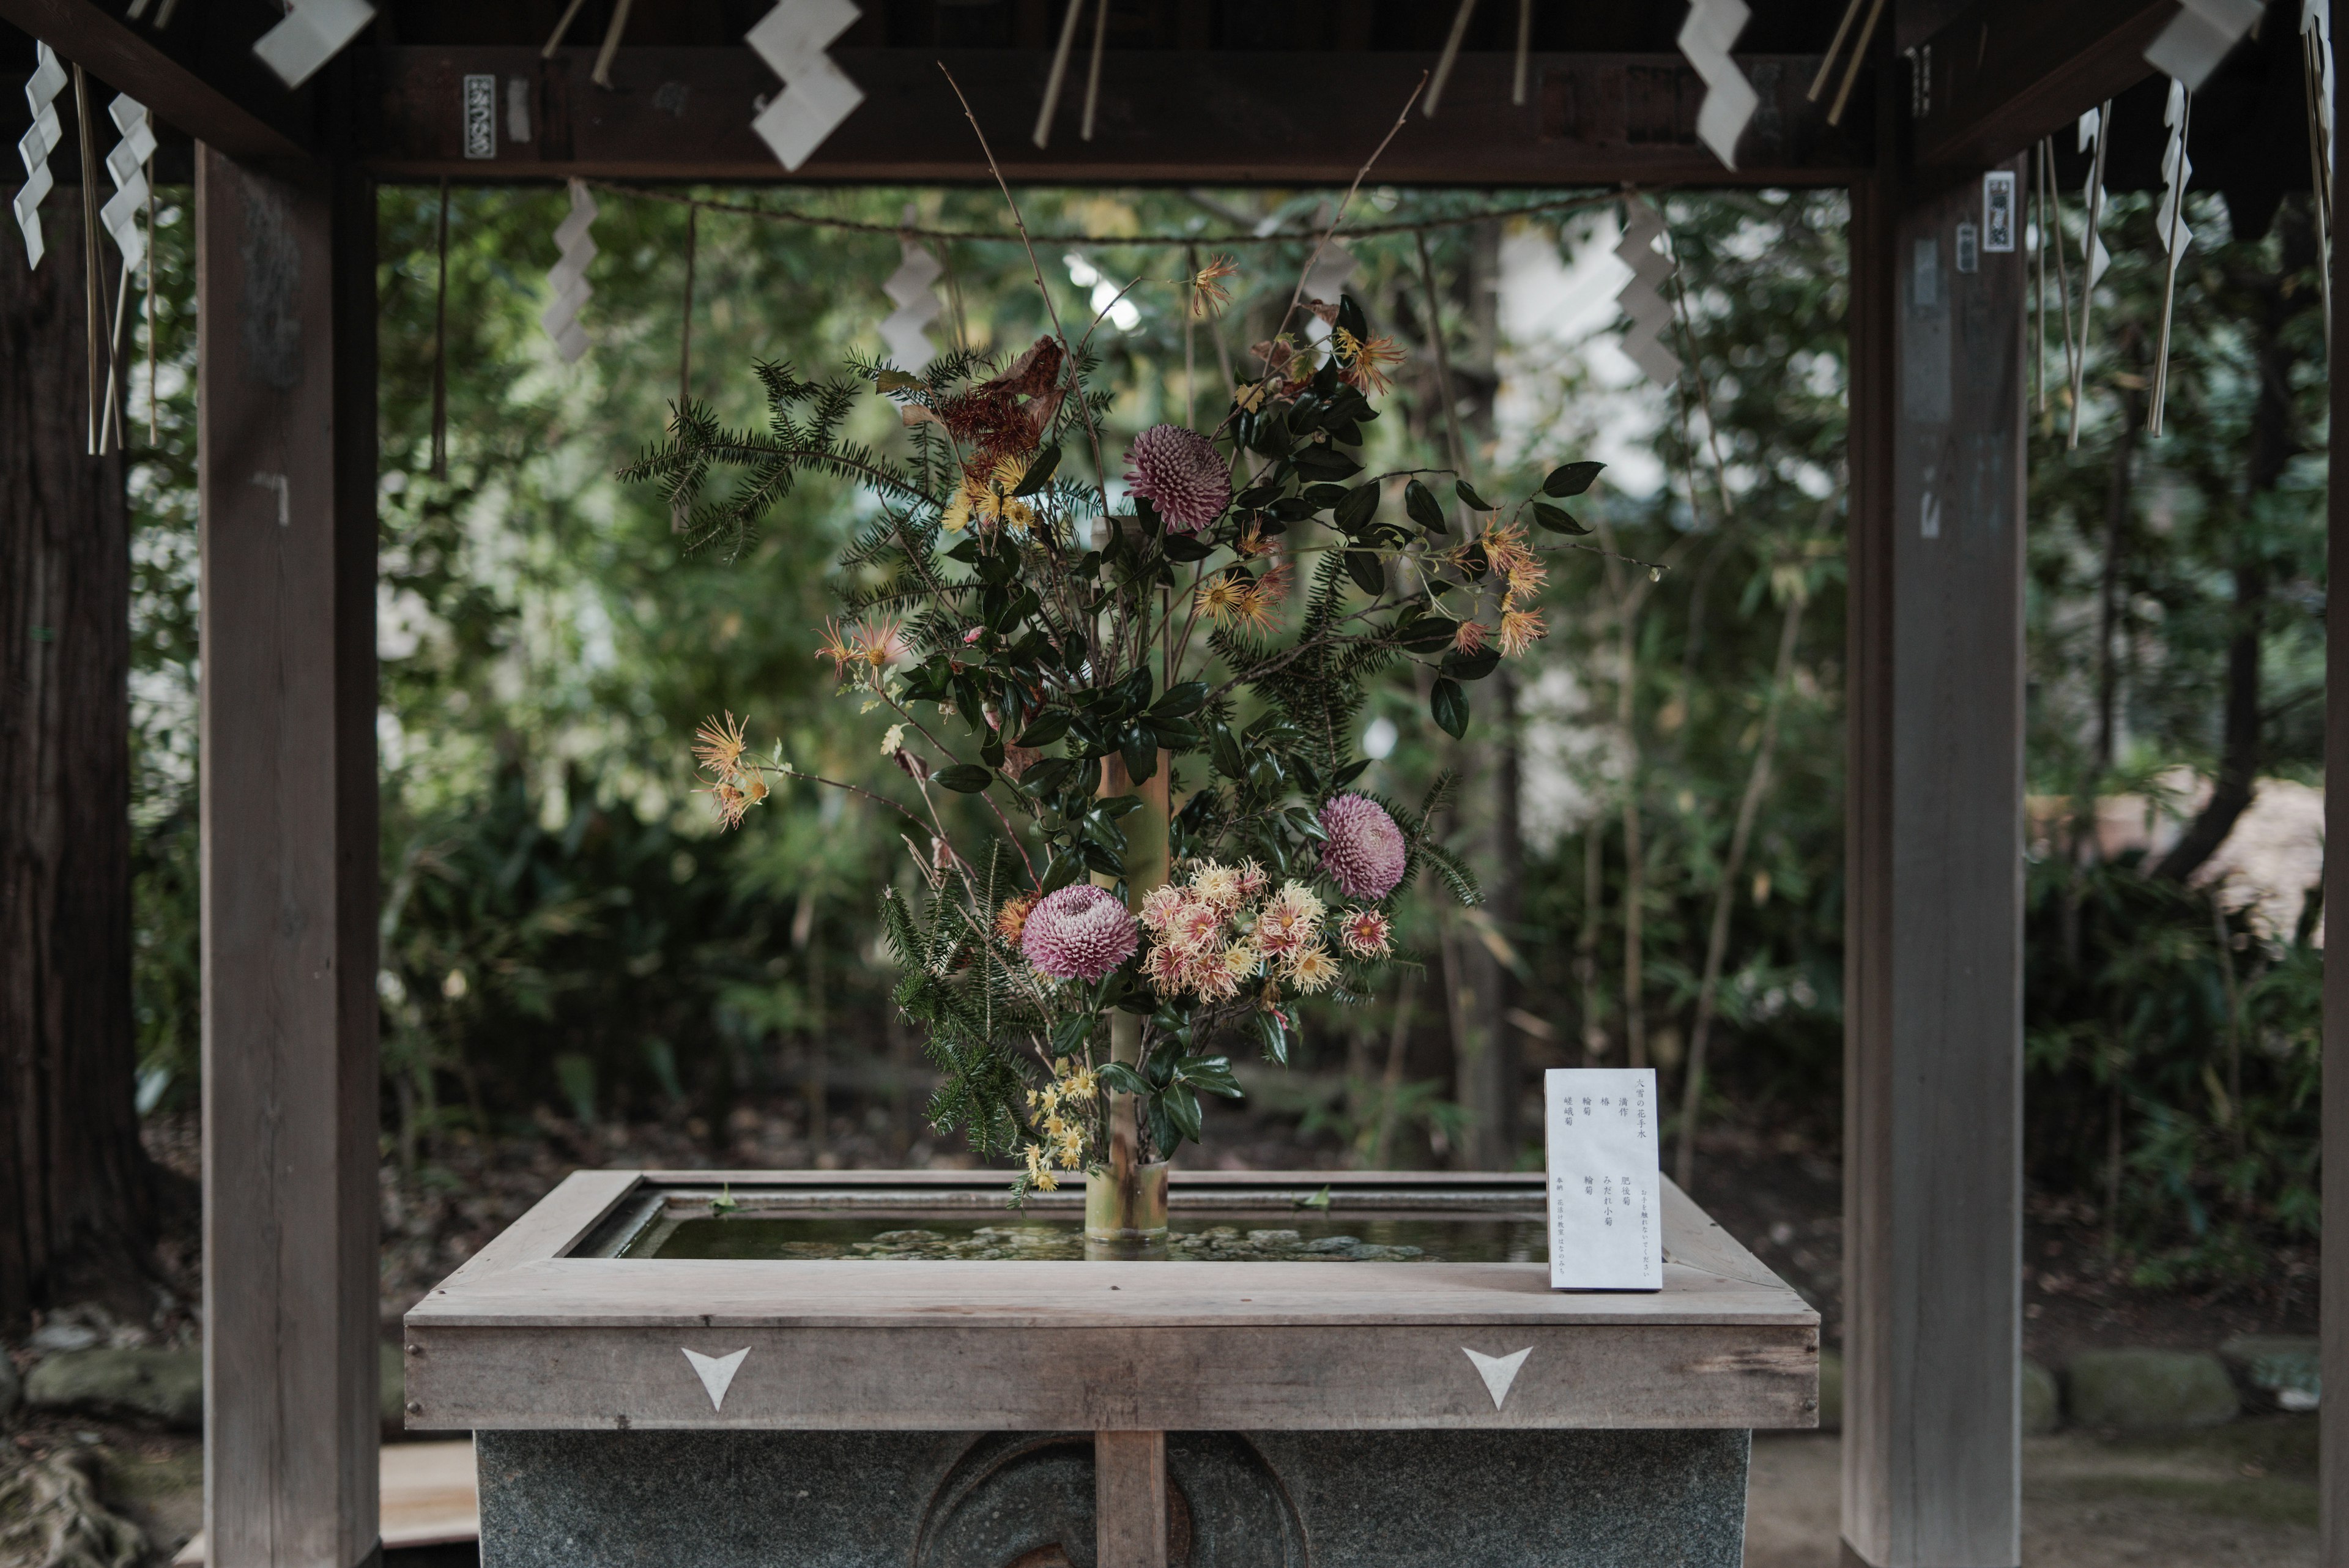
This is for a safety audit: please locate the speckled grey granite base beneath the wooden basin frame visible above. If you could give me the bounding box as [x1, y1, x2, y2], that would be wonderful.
[477, 1429, 1750, 1568]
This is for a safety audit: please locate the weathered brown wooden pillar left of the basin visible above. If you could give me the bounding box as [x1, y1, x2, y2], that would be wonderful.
[195, 148, 378, 1568]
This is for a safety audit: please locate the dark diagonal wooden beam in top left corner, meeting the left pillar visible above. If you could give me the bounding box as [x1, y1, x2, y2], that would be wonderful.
[0, 0, 317, 162]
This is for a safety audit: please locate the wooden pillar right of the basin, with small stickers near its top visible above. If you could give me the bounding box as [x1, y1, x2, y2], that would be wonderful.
[1844, 172, 2025, 1568]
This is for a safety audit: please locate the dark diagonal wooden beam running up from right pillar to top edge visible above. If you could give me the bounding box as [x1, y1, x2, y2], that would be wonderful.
[1902, 0, 2178, 169]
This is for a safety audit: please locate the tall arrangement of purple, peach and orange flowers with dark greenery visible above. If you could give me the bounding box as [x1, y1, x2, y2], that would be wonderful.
[623, 230, 1600, 1194]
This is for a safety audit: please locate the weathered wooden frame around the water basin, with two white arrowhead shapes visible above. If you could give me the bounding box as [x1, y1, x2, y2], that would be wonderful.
[406, 1171, 1818, 1432]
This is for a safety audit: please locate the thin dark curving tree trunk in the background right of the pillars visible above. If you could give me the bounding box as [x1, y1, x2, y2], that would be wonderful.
[2154, 202, 2318, 882]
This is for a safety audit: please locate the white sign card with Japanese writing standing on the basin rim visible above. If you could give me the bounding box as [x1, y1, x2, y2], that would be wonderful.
[1541, 1068, 1663, 1291]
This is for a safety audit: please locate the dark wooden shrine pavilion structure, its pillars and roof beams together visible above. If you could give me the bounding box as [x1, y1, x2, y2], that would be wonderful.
[0, 0, 2349, 1568]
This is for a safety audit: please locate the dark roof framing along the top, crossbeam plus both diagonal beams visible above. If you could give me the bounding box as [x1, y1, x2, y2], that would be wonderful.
[0, 0, 2178, 186]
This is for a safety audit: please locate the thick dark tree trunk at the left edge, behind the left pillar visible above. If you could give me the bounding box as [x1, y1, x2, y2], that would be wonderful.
[0, 188, 155, 1326]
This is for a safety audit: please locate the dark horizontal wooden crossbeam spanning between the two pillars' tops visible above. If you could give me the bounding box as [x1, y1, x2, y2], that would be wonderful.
[352, 45, 1870, 186]
